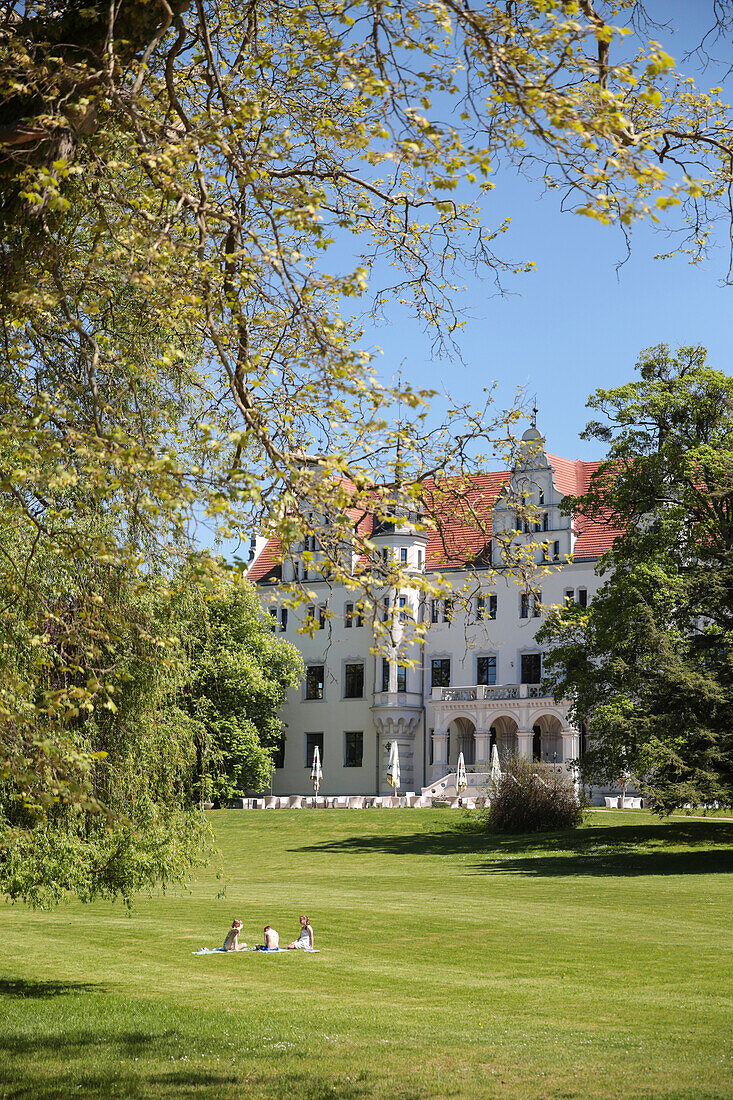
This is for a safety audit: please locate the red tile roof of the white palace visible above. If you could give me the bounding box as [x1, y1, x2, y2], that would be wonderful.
[247, 454, 621, 583]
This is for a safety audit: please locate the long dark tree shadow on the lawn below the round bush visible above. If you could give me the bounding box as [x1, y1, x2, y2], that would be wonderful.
[291, 818, 733, 876]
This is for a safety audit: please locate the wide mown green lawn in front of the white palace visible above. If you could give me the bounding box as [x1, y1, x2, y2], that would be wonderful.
[0, 811, 733, 1100]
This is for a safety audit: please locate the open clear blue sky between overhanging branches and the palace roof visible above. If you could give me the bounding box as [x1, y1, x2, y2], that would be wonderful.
[356, 0, 733, 459]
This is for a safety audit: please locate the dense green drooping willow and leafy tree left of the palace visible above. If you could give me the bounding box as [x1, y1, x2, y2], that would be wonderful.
[0, 554, 300, 905]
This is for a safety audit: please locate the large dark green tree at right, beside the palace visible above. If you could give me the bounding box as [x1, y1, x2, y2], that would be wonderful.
[539, 345, 733, 811]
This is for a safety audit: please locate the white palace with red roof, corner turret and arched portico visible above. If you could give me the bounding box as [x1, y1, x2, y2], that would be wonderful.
[248, 428, 616, 795]
